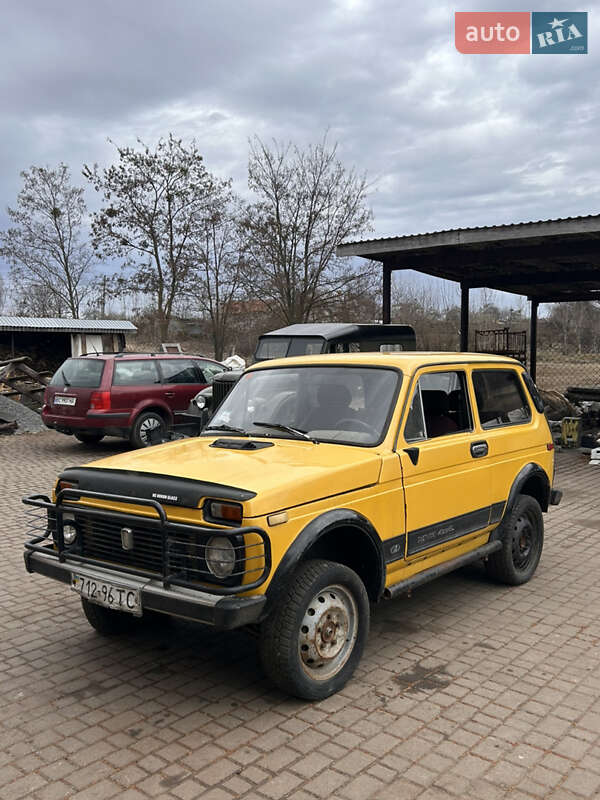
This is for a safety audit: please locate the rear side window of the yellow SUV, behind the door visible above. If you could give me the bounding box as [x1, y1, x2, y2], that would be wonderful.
[473, 369, 531, 429]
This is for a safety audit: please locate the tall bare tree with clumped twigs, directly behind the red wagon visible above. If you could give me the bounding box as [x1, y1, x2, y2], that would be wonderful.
[83, 134, 228, 341]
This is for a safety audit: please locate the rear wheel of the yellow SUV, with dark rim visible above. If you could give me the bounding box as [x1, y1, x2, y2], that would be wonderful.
[486, 494, 544, 586]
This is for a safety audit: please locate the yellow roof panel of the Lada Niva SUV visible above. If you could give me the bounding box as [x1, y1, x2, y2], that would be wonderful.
[250, 350, 523, 374]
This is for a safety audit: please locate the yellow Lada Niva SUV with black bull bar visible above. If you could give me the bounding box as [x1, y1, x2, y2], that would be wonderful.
[24, 352, 560, 699]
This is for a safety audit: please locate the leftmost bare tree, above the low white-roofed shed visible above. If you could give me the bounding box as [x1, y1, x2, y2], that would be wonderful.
[0, 164, 93, 318]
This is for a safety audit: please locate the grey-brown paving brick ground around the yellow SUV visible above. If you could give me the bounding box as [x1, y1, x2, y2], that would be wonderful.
[0, 433, 600, 800]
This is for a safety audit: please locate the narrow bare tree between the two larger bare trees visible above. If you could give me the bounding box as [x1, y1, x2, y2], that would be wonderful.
[194, 194, 244, 361]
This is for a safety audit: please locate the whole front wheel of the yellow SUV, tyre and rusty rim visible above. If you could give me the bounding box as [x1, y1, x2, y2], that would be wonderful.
[260, 560, 369, 700]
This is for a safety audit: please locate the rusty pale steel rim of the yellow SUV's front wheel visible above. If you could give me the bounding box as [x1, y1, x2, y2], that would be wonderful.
[298, 584, 358, 681]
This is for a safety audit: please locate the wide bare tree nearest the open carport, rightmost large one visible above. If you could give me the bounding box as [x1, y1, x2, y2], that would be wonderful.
[246, 138, 372, 323]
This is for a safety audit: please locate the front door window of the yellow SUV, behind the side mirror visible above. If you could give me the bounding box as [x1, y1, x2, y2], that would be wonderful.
[404, 371, 473, 441]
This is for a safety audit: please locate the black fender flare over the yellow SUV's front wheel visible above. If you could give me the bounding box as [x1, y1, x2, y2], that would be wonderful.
[266, 508, 385, 613]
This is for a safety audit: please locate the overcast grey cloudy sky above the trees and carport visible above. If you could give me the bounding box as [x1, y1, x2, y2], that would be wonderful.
[0, 0, 600, 306]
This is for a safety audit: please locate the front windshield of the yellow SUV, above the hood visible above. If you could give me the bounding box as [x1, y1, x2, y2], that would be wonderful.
[206, 367, 400, 446]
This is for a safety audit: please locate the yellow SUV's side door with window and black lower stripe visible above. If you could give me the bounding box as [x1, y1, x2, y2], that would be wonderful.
[399, 367, 491, 561]
